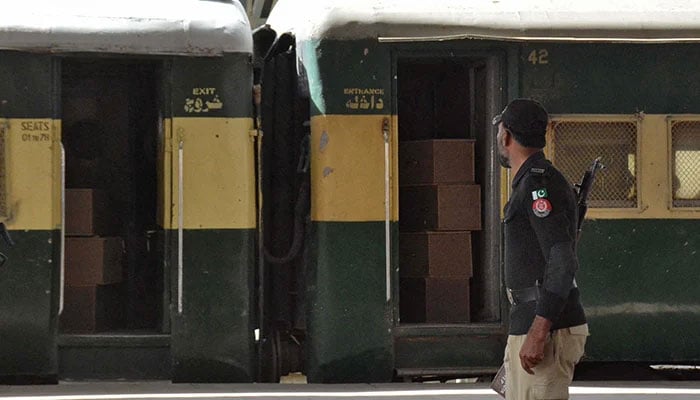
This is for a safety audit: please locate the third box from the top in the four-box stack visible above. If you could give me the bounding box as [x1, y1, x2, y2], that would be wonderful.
[399, 231, 472, 278]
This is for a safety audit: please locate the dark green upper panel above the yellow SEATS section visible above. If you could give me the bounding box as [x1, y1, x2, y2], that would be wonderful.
[0, 51, 56, 118]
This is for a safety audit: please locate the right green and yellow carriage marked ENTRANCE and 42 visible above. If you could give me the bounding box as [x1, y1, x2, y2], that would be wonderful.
[254, 0, 700, 382]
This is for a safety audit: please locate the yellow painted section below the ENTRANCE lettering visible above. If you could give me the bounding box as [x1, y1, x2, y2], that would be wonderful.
[311, 115, 398, 222]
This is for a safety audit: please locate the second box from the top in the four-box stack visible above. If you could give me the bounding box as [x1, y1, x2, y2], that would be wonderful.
[399, 185, 481, 231]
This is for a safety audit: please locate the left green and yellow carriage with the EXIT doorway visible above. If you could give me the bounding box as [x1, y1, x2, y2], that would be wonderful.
[0, 0, 256, 382]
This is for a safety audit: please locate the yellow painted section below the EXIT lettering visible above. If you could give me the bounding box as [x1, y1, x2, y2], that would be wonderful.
[158, 118, 256, 229]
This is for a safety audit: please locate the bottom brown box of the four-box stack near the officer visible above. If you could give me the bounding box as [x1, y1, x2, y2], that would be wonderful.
[399, 278, 470, 323]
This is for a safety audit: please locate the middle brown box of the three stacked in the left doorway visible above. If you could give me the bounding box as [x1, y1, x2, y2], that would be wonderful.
[66, 236, 123, 286]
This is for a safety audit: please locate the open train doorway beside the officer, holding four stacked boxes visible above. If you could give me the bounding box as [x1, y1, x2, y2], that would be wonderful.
[396, 56, 501, 326]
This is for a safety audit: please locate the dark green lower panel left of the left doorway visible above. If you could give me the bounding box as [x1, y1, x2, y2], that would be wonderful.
[0, 231, 60, 377]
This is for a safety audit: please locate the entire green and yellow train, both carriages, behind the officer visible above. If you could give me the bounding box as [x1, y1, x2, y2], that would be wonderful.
[0, 0, 700, 382]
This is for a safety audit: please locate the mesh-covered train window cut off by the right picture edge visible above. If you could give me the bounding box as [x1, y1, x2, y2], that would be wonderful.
[669, 119, 700, 208]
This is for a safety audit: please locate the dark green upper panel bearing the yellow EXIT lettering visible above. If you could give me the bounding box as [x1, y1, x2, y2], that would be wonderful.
[171, 54, 253, 118]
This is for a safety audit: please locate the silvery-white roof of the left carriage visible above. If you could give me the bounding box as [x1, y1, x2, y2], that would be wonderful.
[0, 0, 253, 56]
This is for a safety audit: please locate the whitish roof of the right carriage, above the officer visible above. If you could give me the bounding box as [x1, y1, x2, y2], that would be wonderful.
[268, 0, 700, 43]
